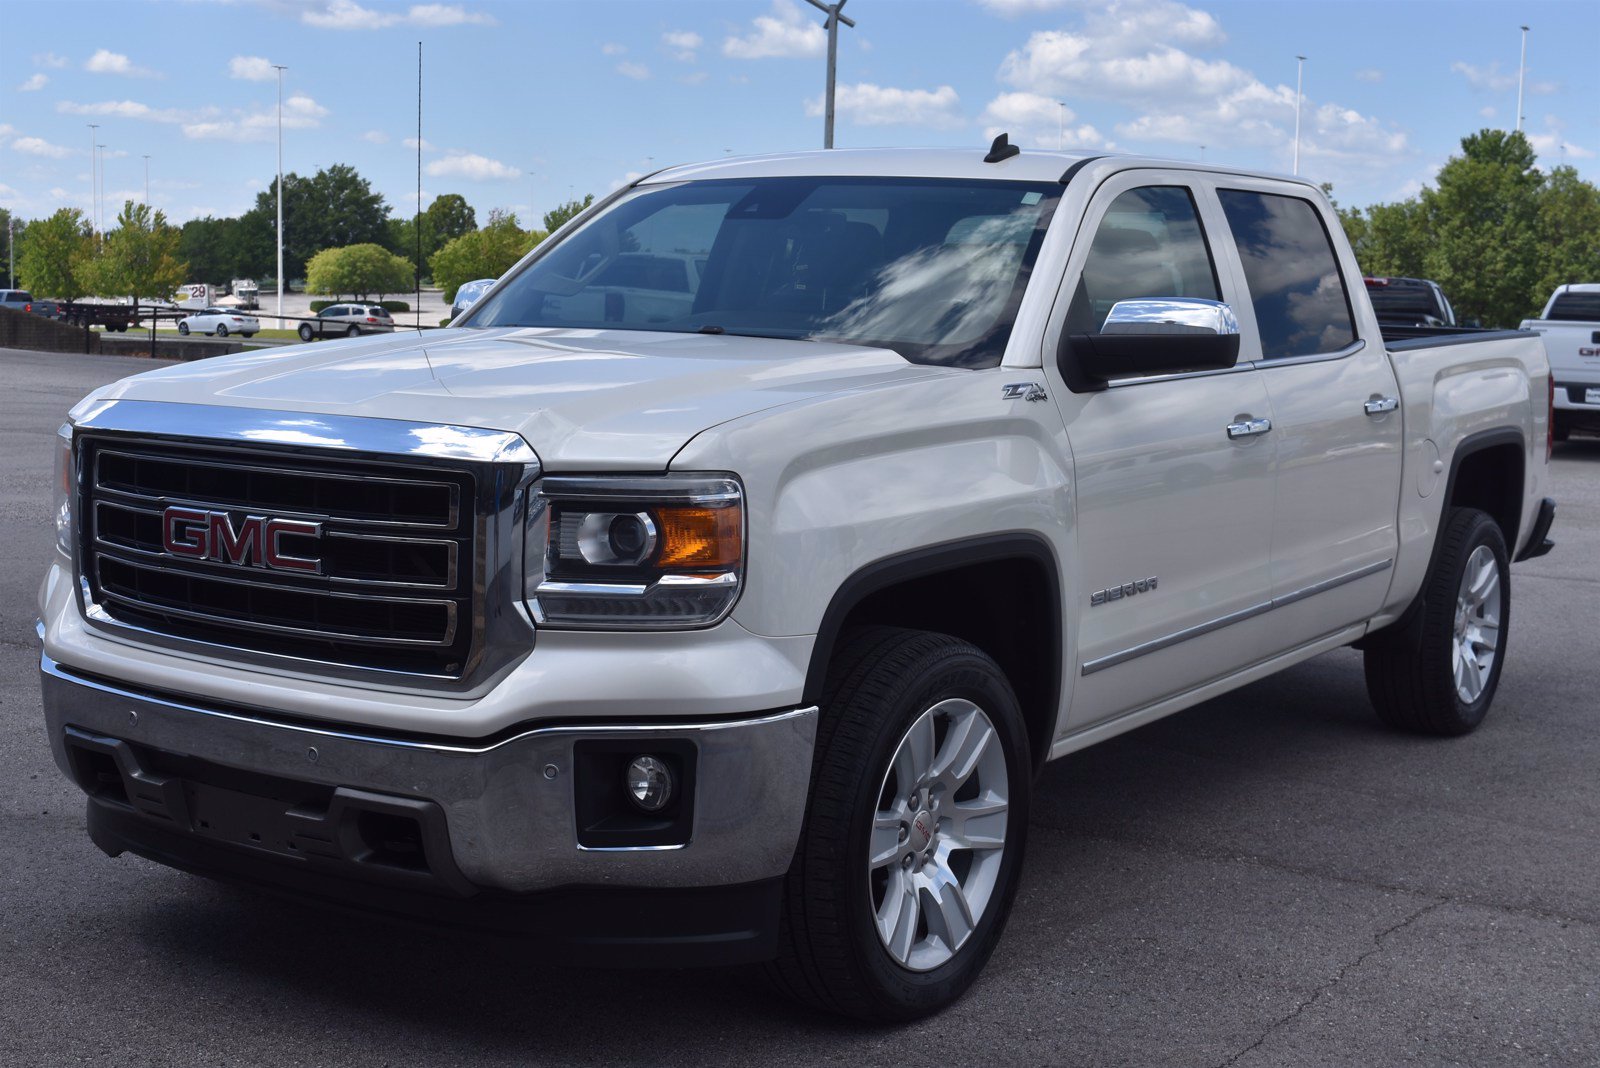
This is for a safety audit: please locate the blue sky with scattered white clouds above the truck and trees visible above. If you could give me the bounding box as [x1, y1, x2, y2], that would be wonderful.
[0, 0, 1600, 225]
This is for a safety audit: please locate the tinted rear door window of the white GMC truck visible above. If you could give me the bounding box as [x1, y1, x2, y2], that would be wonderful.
[1218, 189, 1355, 360]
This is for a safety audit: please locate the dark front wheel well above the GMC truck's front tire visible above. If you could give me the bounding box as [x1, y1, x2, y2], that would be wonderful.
[806, 542, 1061, 769]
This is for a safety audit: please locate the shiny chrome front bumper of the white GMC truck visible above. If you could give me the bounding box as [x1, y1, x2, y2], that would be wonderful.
[40, 656, 818, 894]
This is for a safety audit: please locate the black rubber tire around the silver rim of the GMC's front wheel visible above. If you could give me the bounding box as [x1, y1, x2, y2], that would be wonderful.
[768, 627, 1034, 1022]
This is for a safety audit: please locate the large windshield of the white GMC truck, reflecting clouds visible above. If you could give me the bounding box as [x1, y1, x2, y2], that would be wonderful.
[466, 177, 1061, 366]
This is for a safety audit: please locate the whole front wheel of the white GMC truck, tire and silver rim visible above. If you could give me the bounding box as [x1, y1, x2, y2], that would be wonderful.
[771, 627, 1032, 1020]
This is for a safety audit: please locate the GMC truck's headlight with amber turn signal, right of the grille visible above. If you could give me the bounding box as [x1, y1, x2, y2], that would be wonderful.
[523, 475, 744, 630]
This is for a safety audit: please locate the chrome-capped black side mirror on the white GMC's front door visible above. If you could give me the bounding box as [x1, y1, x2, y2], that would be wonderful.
[1056, 297, 1238, 393]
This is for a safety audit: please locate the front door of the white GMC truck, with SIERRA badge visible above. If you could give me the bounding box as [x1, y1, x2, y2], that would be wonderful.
[1045, 169, 1277, 731]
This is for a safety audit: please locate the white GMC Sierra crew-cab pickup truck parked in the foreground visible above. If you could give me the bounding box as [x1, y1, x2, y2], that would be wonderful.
[40, 137, 1554, 1018]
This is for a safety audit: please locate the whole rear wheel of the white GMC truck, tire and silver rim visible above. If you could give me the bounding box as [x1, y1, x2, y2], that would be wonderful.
[1365, 508, 1510, 735]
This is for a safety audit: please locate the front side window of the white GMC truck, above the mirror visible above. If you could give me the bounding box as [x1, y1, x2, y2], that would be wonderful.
[1066, 185, 1222, 334]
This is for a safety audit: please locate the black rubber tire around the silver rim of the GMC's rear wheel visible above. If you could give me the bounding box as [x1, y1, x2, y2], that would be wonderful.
[1365, 508, 1510, 737]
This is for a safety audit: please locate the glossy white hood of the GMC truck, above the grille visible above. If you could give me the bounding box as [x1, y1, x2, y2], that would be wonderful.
[99, 328, 950, 470]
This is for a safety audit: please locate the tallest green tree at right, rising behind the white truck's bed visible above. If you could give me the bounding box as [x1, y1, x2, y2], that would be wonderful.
[1419, 130, 1544, 326]
